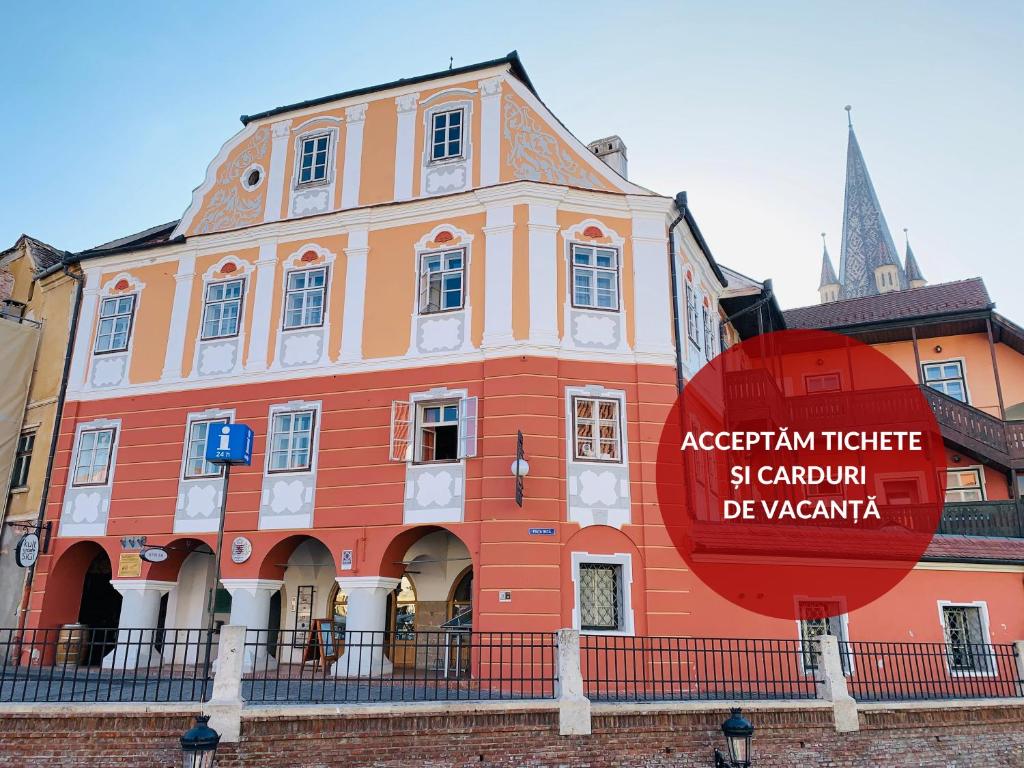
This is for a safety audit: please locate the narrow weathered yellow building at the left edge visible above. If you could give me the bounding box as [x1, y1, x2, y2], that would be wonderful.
[0, 234, 80, 627]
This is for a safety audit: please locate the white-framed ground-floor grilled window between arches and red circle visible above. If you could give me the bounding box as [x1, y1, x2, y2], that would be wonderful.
[571, 552, 634, 635]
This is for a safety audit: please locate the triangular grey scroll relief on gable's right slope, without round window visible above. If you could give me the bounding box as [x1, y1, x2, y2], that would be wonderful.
[502, 95, 604, 189]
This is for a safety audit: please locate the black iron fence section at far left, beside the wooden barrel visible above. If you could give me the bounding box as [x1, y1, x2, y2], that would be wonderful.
[0, 627, 216, 702]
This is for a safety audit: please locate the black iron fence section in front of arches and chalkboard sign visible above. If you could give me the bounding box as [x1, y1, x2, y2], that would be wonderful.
[242, 628, 558, 702]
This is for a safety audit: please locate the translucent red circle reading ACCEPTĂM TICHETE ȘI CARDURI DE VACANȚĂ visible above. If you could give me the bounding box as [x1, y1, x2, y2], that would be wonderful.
[657, 331, 945, 618]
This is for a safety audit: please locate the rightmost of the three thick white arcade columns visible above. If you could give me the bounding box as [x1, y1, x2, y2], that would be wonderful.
[331, 577, 400, 677]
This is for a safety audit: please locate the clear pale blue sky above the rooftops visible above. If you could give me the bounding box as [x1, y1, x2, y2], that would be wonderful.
[0, 0, 1024, 315]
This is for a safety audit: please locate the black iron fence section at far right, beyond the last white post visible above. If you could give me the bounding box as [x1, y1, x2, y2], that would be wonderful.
[839, 641, 1024, 701]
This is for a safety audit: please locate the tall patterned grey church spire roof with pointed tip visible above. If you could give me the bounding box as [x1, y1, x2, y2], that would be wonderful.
[839, 118, 909, 299]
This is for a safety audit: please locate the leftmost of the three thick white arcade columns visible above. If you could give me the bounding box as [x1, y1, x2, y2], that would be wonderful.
[101, 579, 174, 670]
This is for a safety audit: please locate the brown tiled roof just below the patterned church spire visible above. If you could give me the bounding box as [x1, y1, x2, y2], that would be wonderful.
[783, 278, 994, 329]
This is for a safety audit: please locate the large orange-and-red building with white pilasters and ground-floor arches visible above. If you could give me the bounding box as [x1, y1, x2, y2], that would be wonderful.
[22, 53, 1024, 679]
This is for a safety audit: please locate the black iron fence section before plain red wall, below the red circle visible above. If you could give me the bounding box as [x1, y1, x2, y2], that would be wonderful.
[580, 635, 816, 701]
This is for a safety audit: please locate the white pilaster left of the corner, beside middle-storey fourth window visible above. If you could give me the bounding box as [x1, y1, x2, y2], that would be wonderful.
[483, 205, 515, 347]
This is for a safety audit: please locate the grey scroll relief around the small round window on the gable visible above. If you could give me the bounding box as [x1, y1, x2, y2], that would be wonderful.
[191, 126, 270, 234]
